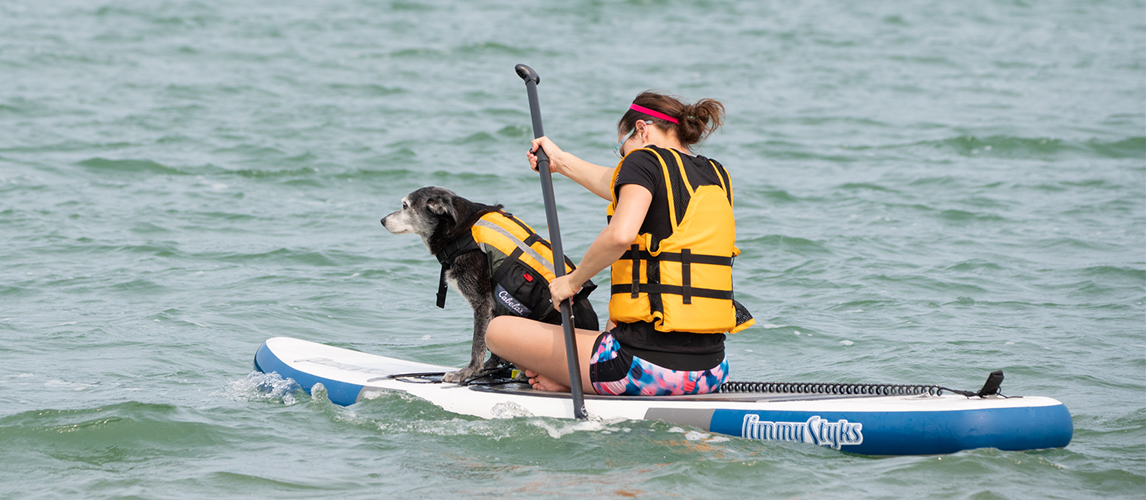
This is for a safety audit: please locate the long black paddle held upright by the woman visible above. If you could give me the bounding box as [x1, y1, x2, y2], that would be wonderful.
[513, 64, 587, 419]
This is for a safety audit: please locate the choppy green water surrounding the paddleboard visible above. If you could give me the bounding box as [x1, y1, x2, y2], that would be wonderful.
[0, 0, 1146, 499]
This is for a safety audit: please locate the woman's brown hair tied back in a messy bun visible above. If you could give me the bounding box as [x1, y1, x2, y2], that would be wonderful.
[617, 91, 724, 147]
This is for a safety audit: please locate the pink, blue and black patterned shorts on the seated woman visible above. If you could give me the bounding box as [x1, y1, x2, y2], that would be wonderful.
[589, 331, 728, 396]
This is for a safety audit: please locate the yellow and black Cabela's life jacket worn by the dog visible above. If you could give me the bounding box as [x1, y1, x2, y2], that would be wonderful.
[435, 210, 597, 329]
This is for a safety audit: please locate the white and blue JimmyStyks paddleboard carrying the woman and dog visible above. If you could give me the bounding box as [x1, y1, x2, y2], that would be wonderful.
[254, 337, 1074, 455]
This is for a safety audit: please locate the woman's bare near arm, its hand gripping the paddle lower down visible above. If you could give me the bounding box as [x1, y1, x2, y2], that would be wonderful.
[549, 183, 652, 304]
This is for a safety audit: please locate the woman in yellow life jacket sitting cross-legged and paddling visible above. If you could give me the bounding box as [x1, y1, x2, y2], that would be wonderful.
[486, 92, 753, 396]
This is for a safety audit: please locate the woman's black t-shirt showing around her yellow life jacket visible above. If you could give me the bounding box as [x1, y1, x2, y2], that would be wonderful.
[613, 146, 731, 370]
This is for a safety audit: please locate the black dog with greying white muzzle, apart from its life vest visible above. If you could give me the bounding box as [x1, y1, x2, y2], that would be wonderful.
[382, 186, 598, 383]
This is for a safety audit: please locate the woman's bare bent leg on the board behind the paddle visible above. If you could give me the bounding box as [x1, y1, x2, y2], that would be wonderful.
[486, 317, 601, 394]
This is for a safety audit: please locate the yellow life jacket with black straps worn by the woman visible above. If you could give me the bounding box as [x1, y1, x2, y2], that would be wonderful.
[607, 148, 755, 334]
